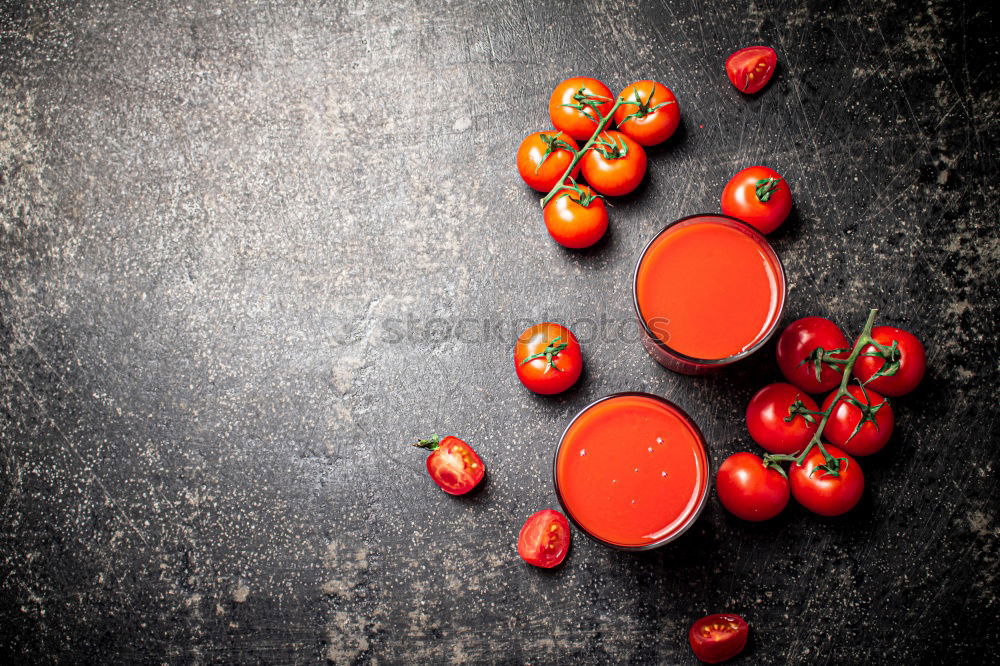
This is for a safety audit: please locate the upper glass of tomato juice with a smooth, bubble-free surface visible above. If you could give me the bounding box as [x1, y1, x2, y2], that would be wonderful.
[632, 214, 786, 375]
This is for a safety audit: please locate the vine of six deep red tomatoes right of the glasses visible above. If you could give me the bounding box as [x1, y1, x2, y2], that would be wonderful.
[716, 316, 927, 521]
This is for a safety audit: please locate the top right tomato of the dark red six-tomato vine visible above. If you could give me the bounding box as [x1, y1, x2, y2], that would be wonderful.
[854, 326, 927, 396]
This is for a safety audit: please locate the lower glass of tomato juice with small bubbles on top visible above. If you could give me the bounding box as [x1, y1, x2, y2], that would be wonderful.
[553, 393, 710, 550]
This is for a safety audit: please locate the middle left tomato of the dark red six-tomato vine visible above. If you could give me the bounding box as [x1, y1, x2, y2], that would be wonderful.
[747, 382, 819, 454]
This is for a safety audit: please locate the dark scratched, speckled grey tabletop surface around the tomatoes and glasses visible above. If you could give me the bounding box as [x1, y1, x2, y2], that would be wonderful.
[0, 0, 1000, 664]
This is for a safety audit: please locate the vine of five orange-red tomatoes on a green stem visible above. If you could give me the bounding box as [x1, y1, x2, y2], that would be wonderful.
[517, 76, 681, 249]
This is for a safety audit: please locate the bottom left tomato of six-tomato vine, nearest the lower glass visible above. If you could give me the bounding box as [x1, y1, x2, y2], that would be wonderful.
[715, 453, 789, 522]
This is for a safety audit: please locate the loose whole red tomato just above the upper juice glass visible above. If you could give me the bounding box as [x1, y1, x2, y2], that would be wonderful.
[724, 166, 792, 234]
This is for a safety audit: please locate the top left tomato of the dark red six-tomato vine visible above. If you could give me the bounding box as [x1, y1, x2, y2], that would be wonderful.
[777, 317, 852, 393]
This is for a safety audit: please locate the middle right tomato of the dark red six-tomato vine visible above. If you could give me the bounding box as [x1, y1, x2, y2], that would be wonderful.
[823, 384, 896, 456]
